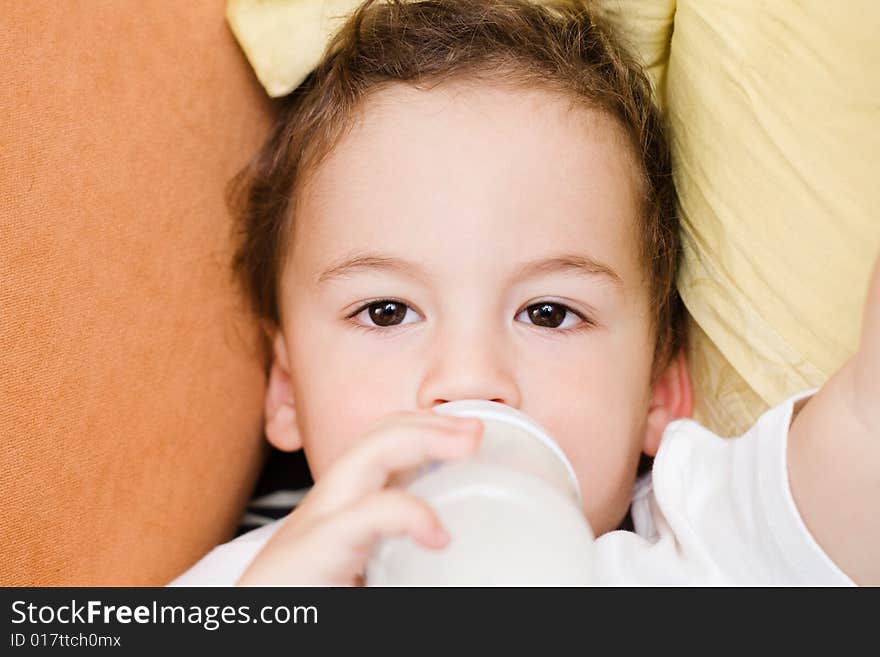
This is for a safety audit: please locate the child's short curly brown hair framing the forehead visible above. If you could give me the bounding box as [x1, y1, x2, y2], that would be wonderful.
[230, 0, 684, 380]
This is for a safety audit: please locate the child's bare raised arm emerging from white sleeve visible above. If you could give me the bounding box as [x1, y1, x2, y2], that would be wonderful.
[788, 251, 880, 585]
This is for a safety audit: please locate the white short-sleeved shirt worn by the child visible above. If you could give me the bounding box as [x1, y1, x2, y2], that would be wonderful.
[170, 390, 853, 586]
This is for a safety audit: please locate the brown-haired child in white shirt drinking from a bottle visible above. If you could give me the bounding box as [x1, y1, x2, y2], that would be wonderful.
[174, 0, 880, 585]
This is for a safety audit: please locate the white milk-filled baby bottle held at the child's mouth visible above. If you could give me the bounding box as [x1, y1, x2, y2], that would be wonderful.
[366, 400, 593, 586]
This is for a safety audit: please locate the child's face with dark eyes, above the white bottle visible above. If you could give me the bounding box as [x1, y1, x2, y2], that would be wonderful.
[267, 83, 684, 534]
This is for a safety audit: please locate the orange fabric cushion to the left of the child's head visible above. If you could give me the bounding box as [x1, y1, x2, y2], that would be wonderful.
[0, 0, 273, 585]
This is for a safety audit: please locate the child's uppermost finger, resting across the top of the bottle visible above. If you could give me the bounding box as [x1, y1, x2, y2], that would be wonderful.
[309, 417, 482, 514]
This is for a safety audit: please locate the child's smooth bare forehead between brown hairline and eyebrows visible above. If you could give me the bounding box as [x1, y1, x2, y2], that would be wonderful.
[290, 83, 640, 288]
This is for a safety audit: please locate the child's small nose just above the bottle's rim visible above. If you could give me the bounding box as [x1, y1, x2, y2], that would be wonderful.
[418, 324, 521, 409]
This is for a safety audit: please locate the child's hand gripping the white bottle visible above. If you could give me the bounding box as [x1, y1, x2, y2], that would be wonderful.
[237, 411, 482, 586]
